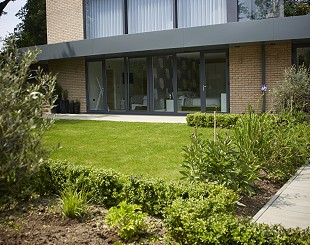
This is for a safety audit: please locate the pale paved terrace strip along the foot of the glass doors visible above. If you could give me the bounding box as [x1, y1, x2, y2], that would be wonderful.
[48, 114, 186, 123]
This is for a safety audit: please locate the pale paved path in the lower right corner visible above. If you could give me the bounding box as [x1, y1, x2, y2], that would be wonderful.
[253, 164, 310, 229]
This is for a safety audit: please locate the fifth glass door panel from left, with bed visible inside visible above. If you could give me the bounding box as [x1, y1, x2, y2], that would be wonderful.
[177, 53, 201, 112]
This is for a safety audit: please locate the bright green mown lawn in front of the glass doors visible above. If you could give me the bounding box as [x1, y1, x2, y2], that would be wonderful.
[44, 120, 224, 180]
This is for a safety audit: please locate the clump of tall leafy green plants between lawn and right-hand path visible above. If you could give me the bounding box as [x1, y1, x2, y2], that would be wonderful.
[180, 108, 273, 194]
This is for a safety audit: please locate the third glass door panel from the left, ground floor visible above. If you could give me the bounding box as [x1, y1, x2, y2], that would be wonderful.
[127, 58, 148, 111]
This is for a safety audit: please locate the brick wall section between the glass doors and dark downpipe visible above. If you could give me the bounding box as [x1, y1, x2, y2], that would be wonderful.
[229, 45, 262, 113]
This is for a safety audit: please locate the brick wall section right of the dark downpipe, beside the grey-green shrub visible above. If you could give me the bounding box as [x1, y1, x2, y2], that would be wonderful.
[265, 42, 292, 111]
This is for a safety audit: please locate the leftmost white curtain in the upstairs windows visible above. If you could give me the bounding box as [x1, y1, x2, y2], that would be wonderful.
[85, 0, 124, 38]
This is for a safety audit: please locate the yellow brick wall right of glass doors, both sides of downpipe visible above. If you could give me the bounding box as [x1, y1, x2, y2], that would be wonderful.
[229, 42, 292, 113]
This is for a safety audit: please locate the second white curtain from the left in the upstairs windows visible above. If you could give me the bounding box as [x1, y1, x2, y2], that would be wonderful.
[128, 0, 174, 33]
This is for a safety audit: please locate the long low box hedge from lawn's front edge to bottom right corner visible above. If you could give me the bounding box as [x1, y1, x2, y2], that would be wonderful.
[32, 160, 310, 244]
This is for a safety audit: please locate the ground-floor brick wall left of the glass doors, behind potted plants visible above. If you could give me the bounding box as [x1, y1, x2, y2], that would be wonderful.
[48, 59, 86, 112]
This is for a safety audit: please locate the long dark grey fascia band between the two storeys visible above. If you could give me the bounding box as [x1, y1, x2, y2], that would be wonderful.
[30, 15, 310, 61]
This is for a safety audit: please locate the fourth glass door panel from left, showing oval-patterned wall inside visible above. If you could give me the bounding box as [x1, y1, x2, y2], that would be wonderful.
[153, 55, 174, 112]
